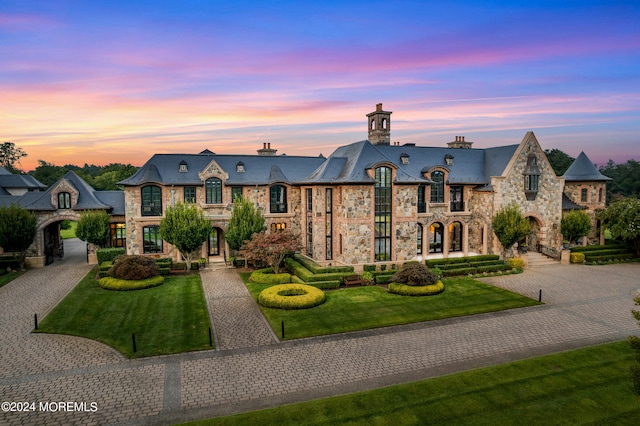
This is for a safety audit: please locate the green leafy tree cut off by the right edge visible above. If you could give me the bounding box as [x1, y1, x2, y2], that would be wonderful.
[598, 198, 640, 256]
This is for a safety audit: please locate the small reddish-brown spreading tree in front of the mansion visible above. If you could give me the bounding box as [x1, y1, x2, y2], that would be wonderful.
[240, 229, 302, 274]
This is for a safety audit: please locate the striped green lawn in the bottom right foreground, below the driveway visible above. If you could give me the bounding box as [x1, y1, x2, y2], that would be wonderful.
[182, 341, 640, 426]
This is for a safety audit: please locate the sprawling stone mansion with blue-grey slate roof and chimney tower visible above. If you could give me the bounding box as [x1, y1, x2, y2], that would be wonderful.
[0, 104, 609, 265]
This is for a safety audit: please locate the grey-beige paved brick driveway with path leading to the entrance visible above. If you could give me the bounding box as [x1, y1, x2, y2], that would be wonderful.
[0, 249, 640, 425]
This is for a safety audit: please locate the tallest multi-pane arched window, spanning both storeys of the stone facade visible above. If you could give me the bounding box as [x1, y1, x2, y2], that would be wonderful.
[374, 167, 392, 261]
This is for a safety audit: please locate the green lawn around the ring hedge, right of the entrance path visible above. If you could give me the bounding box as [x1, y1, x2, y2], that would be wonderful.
[241, 273, 538, 340]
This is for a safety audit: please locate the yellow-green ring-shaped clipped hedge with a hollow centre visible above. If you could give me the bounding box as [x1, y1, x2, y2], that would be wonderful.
[258, 284, 325, 309]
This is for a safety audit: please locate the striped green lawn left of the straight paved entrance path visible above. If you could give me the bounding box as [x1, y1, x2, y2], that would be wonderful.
[38, 271, 212, 358]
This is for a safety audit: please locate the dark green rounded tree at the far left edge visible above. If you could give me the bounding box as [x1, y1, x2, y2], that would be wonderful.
[0, 204, 38, 270]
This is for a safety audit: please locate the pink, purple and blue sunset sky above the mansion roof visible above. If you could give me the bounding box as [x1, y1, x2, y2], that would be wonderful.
[0, 0, 640, 170]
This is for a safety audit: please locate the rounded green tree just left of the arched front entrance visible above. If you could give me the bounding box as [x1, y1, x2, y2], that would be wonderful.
[160, 202, 211, 270]
